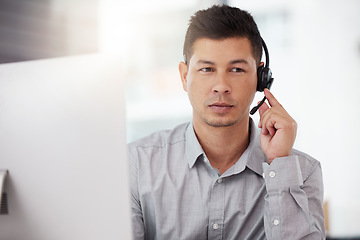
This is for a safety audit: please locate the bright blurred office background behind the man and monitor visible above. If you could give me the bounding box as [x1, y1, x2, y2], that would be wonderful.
[0, 0, 360, 238]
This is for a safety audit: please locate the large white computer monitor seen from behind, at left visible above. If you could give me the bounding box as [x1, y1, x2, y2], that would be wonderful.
[0, 54, 131, 240]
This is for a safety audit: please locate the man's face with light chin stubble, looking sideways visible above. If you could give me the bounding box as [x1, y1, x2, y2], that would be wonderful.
[179, 37, 257, 127]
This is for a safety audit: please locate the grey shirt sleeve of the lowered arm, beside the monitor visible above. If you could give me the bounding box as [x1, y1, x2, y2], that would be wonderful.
[128, 148, 145, 240]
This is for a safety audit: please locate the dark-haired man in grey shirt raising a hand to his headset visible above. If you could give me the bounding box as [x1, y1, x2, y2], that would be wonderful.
[129, 6, 325, 240]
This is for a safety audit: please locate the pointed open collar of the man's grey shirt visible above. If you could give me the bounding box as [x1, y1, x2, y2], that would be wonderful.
[185, 118, 267, 176]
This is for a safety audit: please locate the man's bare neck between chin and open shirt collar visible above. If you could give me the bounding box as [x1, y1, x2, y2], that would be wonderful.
[194, 118, 250, 174]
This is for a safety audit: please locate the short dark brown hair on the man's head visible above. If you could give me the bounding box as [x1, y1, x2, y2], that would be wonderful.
[183, 5, 262, 65]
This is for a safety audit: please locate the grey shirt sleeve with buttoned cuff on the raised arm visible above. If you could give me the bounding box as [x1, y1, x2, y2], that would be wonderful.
[263, 155, 325, 240]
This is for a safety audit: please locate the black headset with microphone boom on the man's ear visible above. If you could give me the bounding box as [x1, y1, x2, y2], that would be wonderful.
[250, 38, 274, 115]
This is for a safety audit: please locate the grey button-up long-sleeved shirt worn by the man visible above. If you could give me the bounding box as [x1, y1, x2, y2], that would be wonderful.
[129, 120, 325, 240]
